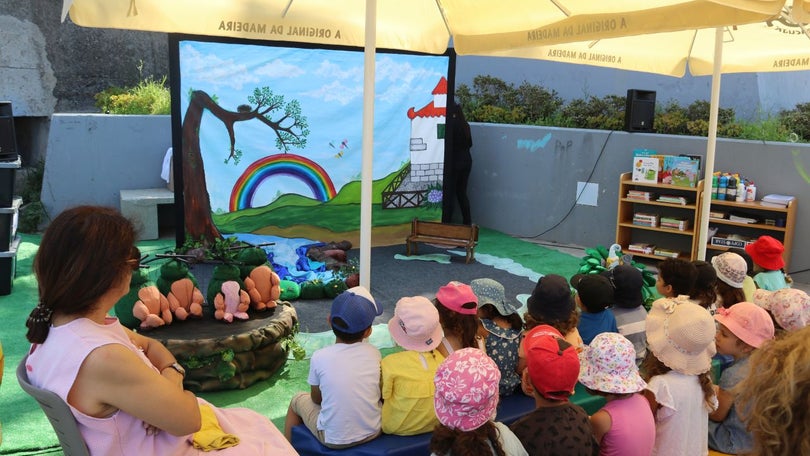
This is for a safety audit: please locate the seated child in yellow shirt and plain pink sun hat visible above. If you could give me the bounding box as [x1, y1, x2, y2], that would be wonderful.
[382, 296, 444, 435]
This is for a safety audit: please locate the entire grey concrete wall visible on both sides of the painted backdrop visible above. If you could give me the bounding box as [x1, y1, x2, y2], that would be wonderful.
[42, 114, 810, 283]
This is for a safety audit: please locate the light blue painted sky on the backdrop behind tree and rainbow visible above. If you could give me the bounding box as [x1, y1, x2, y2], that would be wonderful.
[180, 41, 448, 212]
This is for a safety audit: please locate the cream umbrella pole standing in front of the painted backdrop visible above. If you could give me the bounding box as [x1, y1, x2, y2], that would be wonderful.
[360, 0, 377, 290]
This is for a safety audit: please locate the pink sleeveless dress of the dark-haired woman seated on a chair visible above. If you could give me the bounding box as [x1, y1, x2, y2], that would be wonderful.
[25, 317, 297, 456]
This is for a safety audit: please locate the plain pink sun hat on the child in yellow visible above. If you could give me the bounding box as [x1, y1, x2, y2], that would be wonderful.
[388, 296, 444, 352]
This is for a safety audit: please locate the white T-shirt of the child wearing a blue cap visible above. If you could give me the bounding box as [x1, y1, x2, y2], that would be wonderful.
[307, 342, 382, 445]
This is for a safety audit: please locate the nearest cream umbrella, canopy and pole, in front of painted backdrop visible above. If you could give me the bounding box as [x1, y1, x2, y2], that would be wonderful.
[62, 0, 796, 288]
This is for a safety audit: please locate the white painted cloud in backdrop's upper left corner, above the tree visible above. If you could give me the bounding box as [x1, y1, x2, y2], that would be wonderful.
[180, 45, 259, 90]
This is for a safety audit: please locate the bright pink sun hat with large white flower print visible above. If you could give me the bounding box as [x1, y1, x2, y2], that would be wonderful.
[433, 348, 501, 431]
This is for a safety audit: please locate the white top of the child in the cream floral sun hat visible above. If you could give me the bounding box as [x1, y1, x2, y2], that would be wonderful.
[647, 371, 717, 456]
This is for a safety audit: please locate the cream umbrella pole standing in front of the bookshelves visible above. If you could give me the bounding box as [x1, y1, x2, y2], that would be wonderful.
[697, 27, 724, 260]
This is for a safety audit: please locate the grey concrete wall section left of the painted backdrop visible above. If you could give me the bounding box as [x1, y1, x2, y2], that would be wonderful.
[41, 114, 172, 218]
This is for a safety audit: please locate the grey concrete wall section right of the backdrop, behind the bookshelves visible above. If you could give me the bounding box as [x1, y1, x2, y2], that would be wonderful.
[469, 124, 810, 281]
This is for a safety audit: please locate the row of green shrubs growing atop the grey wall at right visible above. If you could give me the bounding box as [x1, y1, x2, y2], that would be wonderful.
[455, 75, 810, 142]
